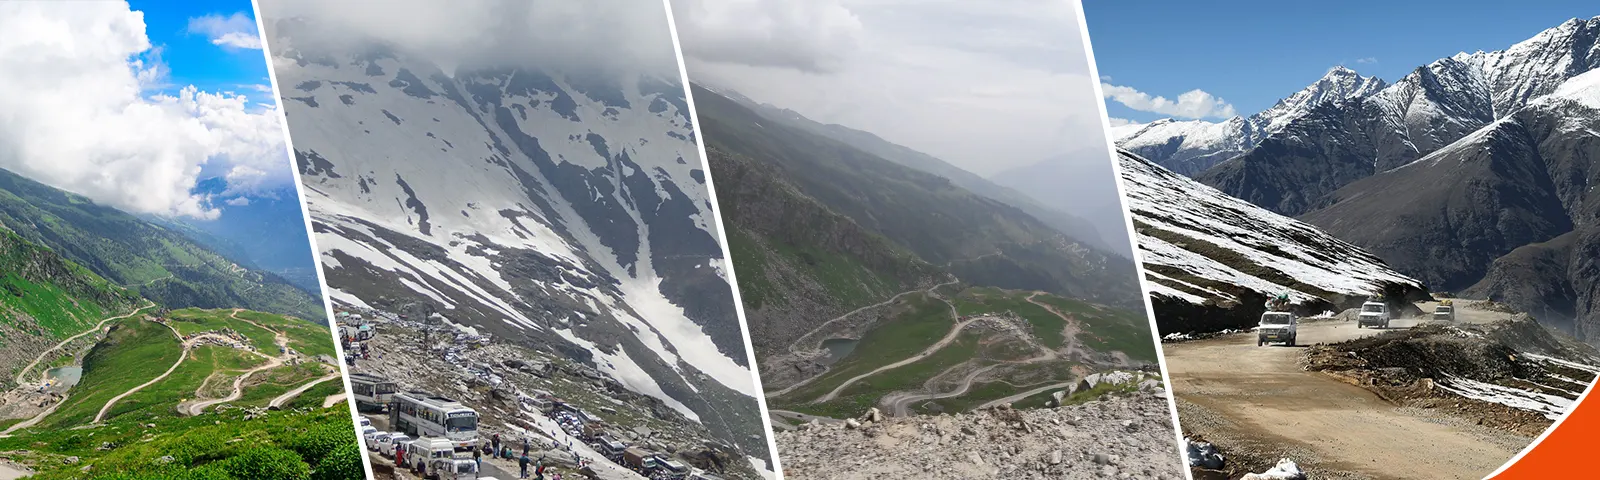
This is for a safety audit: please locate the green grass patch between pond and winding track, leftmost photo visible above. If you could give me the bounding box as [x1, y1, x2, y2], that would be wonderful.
[32, 317, 182, 430]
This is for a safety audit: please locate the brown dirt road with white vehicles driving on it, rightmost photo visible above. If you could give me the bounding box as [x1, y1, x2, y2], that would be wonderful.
[1165, 304, 1531, 478]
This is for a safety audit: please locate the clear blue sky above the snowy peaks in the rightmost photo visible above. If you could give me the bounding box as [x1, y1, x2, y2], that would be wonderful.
[1083, 0, 1600, 122]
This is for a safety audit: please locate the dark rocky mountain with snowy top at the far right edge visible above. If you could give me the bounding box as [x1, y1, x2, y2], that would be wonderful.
[1301, 70, 1600, 341]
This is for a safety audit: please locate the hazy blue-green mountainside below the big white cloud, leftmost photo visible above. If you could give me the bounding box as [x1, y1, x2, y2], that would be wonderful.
[0, 170, 325, 318]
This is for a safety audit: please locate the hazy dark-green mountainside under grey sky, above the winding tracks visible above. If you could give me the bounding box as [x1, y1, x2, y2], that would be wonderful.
[693, 85, 1141, 358]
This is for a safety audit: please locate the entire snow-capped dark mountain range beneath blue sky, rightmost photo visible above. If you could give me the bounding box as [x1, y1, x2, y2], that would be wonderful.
[1118, 18, 1600, 342]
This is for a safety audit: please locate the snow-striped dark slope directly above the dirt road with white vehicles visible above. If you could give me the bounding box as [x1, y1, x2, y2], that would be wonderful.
[1117, 149, 1422, 318]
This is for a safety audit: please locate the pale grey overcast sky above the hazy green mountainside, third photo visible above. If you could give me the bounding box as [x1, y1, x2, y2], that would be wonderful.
[672, 0, 1110, 176]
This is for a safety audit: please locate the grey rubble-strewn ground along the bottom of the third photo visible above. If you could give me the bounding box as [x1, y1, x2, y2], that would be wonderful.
[776, 390, 1184, 480]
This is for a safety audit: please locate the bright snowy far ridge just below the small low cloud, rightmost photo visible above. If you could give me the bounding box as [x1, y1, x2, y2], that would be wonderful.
[1112, 66, 1387, 176]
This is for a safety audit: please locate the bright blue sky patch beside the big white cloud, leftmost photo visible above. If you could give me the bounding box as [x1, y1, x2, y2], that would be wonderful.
[128, 0, 275, 104]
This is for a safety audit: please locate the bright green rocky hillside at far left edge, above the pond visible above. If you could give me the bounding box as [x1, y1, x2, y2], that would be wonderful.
[0, 227, 139, 338]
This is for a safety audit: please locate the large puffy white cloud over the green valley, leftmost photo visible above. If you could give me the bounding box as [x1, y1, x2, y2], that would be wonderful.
[0, 2, 294, 219]
